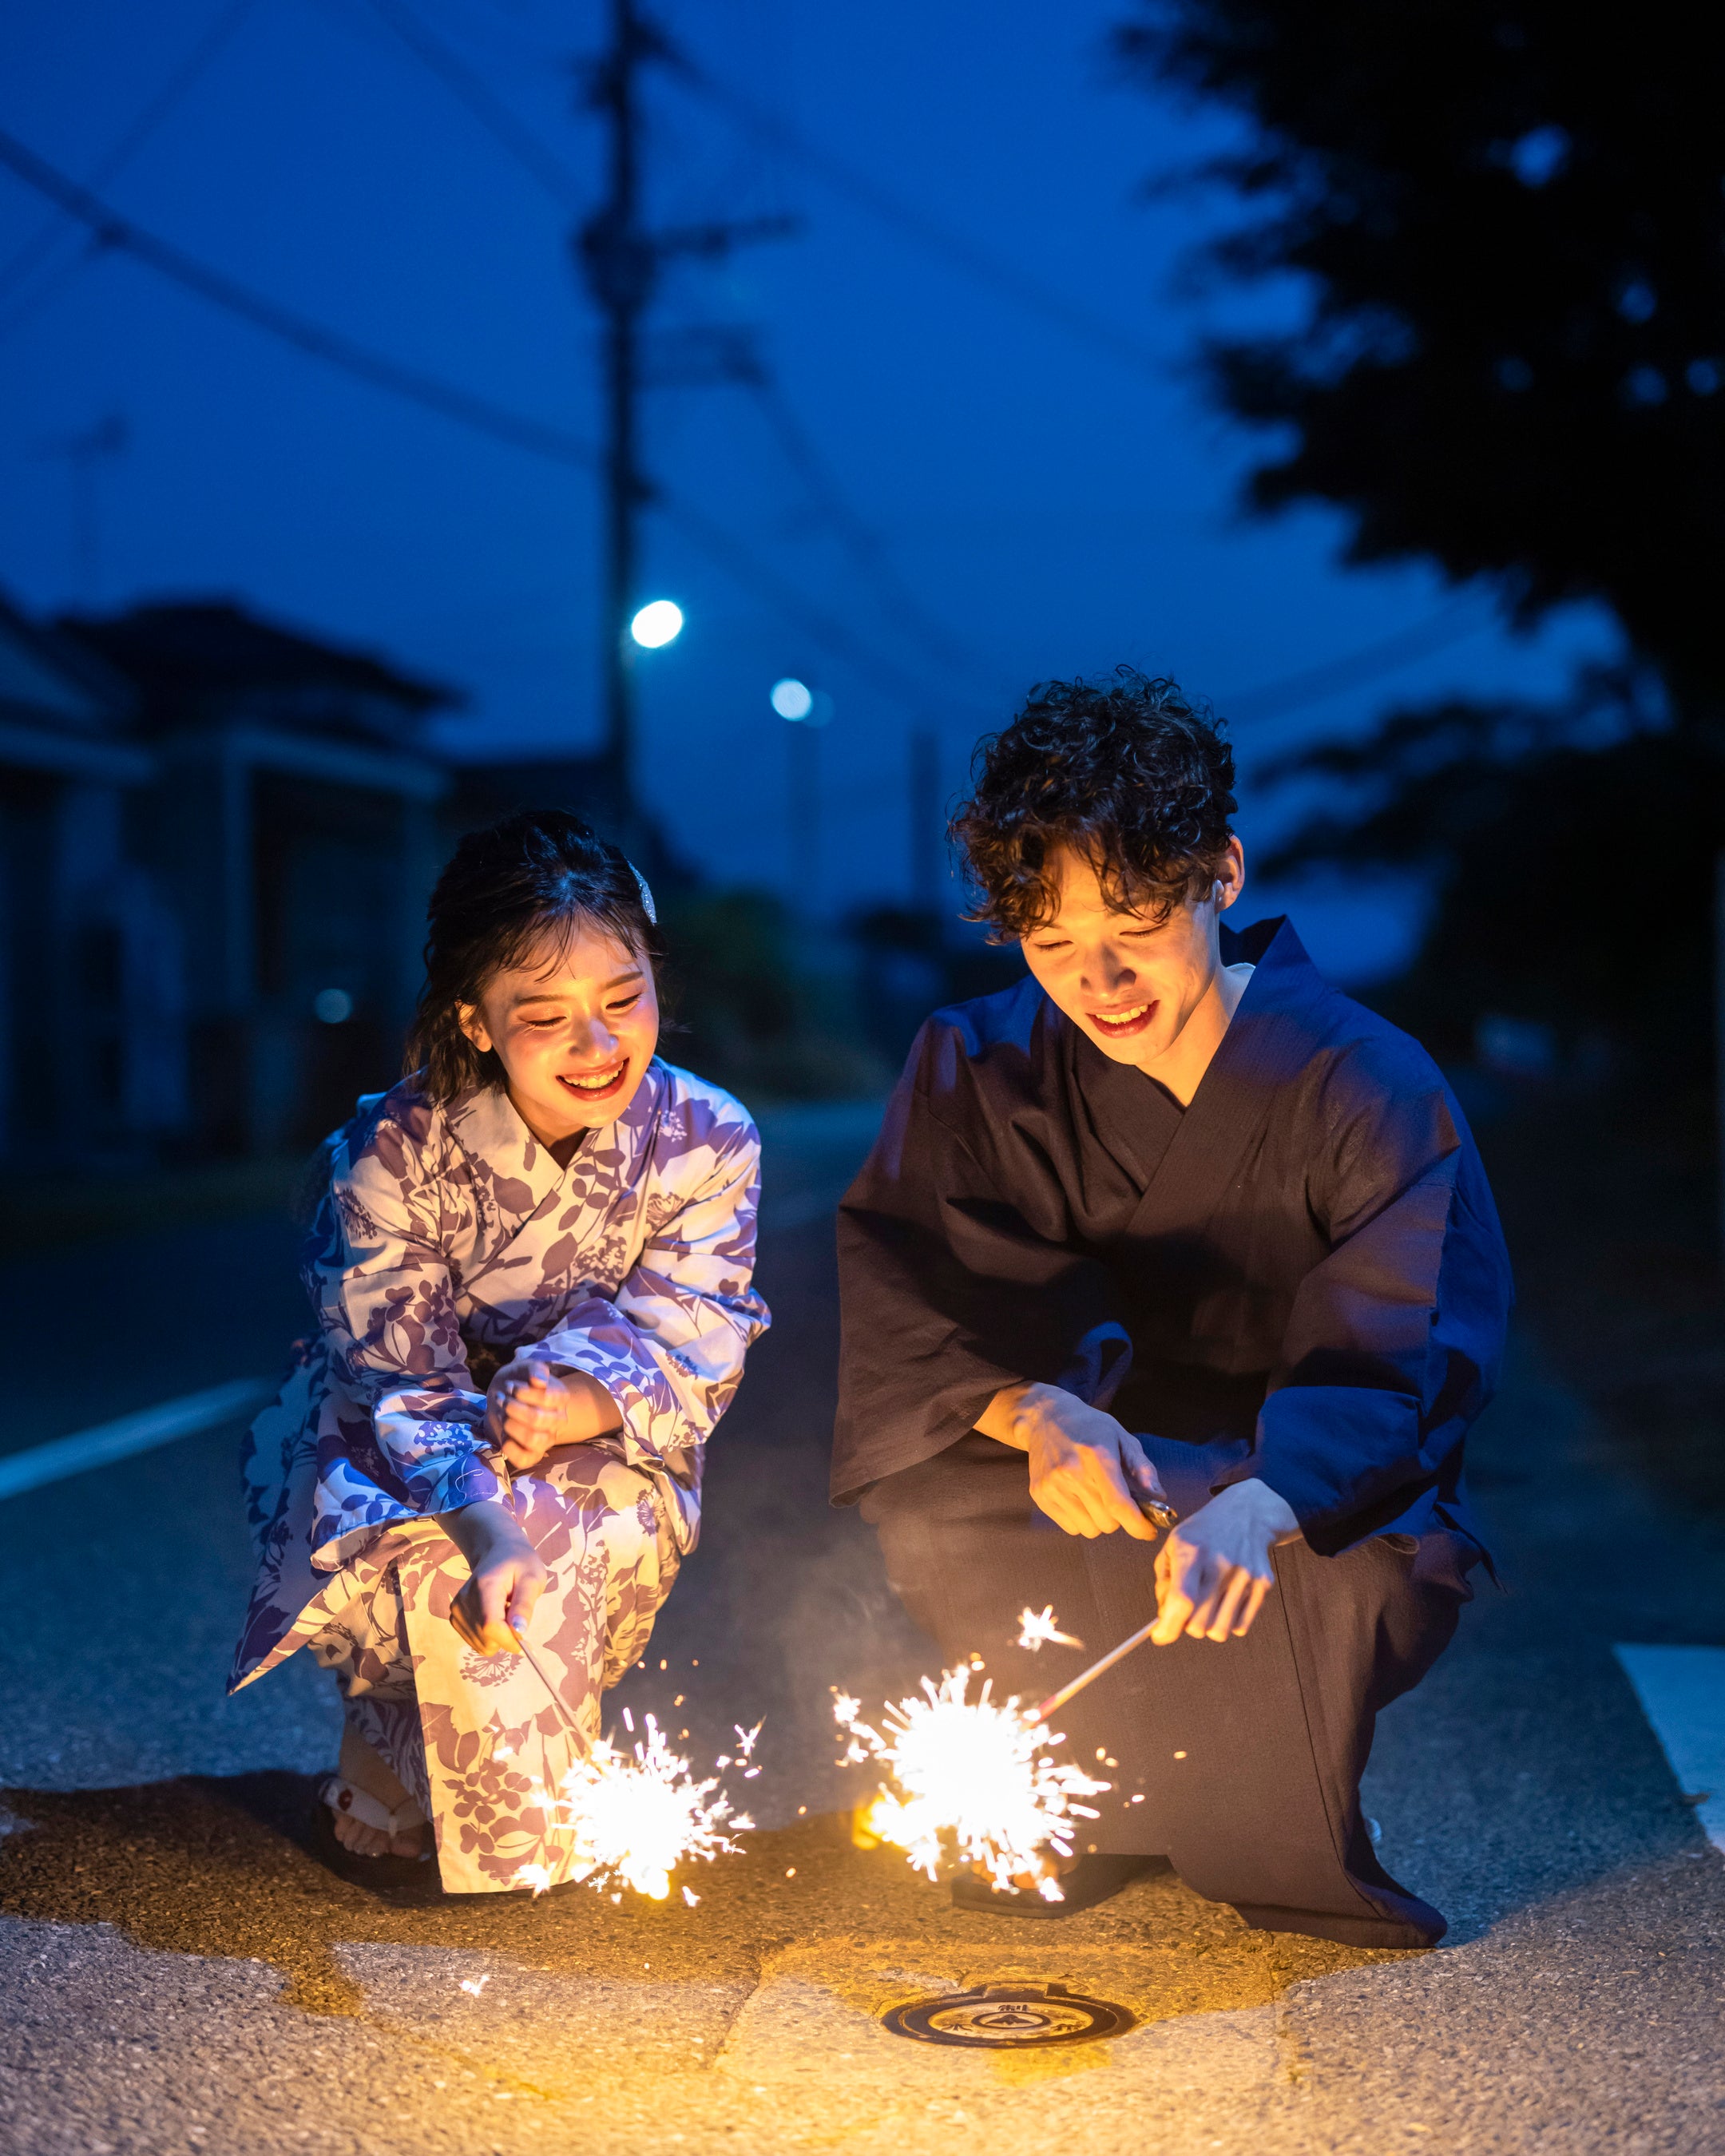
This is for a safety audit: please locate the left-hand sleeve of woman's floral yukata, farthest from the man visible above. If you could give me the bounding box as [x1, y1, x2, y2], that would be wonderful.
[313, 1119, 502, 1516]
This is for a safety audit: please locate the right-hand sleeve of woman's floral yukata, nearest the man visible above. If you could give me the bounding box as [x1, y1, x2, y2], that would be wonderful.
[524, 1124, 772, 1468]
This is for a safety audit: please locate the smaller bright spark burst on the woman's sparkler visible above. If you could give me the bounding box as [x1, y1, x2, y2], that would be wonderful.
[515, 1714, 752, 1901]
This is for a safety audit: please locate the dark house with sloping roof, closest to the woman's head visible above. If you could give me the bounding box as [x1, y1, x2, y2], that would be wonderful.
[61, 600, 459, 1154]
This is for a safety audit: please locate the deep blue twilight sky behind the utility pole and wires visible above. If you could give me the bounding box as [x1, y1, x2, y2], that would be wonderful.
[0, 0, 1611, 973]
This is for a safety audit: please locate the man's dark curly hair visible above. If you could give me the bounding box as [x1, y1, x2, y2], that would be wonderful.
[946, 666, 1235, 942]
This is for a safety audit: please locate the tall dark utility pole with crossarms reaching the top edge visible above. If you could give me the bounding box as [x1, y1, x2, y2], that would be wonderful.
[576, 0, 800, 828]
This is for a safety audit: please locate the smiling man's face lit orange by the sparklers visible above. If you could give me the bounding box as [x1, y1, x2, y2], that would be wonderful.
[1025, 838, 1244, 1069]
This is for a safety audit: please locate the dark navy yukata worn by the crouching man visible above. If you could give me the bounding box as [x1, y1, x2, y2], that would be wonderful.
[832, 921, 1509, 1947]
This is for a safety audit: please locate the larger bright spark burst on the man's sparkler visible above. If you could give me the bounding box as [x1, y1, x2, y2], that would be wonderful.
[832, 1664, 1111, 1901]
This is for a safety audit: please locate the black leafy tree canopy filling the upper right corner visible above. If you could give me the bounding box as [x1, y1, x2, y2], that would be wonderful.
[1117, 0, 1725, 724]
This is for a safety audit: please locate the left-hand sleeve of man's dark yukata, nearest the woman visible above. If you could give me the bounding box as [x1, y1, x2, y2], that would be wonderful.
[832, 1026, 1130, 1505]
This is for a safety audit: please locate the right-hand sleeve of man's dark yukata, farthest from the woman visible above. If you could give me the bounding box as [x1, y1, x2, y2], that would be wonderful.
[1229, 1048, 1512, 1550]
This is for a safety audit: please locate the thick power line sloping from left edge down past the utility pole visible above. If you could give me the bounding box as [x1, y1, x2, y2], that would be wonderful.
[0, 129, 949, 703]
